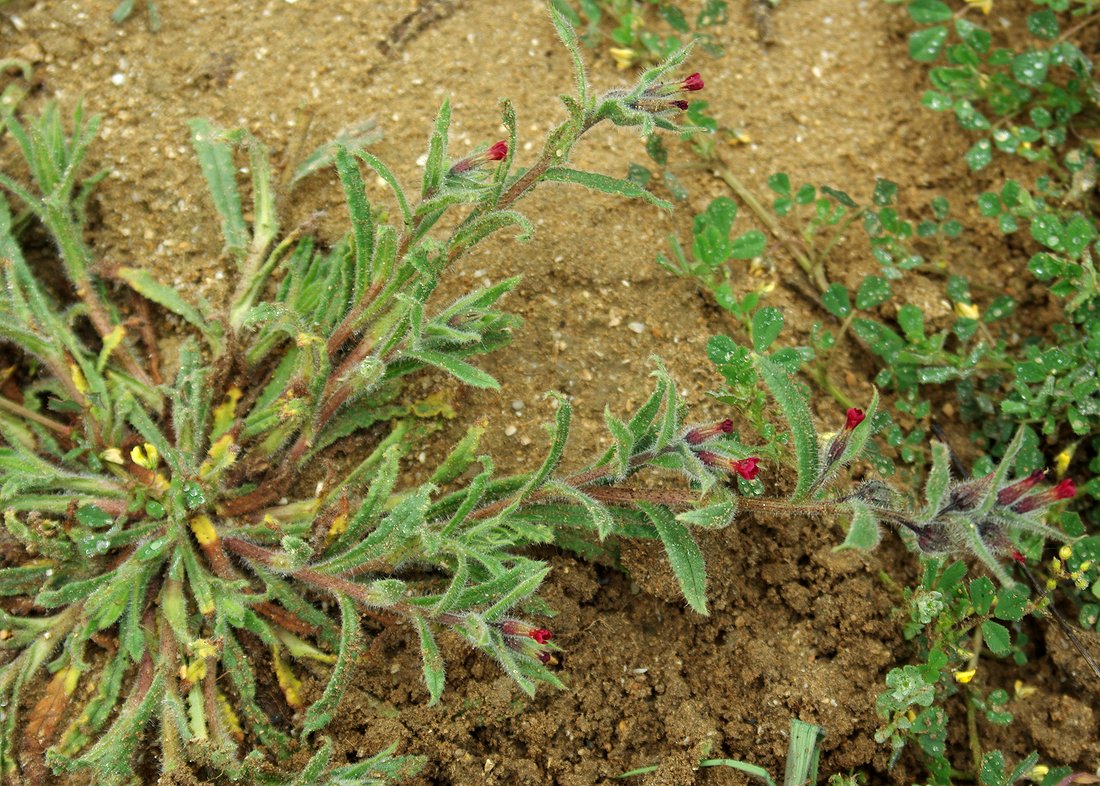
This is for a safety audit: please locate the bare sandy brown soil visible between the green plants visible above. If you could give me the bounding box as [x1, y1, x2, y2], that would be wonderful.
[0, 0, 1100, 786]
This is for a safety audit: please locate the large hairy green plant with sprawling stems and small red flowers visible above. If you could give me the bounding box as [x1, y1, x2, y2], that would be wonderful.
[0, 13, 739, 783]
